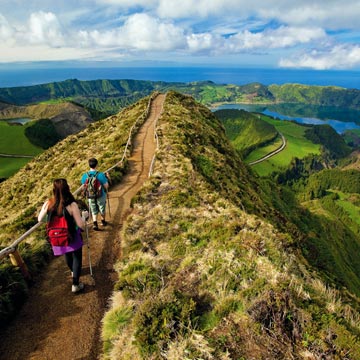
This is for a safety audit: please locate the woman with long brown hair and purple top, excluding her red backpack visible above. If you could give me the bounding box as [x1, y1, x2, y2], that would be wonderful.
[38, 179, 86, 293]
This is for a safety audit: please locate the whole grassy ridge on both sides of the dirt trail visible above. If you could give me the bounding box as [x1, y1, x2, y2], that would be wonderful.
[0, 92, 360, 359]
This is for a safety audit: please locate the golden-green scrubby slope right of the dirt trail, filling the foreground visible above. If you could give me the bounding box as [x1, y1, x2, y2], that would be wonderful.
[102, 93, 360, 360]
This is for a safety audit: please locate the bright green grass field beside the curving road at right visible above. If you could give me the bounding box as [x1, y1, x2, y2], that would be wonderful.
[245, 115, 320, 176]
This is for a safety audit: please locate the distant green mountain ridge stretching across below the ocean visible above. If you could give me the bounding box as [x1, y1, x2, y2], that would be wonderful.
[0, 79, 360, 115]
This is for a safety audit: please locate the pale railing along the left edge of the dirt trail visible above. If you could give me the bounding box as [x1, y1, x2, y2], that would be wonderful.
[0, 92, 159, 260]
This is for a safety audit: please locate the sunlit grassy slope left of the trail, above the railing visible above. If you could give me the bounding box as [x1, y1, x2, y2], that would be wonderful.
[0, 94, 148, 244]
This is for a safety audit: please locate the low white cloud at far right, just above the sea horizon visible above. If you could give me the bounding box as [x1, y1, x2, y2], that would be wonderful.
[279, 44, 360, 70]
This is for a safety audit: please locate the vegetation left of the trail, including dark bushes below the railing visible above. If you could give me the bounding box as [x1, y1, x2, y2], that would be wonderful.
[0, 94, 149, 326]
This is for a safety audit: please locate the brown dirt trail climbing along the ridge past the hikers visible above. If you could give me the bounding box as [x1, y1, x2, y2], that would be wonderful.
[0, 95, 165, 360]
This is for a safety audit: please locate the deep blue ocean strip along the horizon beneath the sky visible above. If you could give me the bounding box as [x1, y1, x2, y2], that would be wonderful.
[0, 65, 360, 89]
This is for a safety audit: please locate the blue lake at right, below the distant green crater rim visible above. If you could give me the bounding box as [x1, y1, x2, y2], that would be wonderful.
[215, 104, 360, 134]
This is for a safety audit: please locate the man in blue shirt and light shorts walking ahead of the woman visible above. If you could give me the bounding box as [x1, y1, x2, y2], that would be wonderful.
[81, 158, 109, 230]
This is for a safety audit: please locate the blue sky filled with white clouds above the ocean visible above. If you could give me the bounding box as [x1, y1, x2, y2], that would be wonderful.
[0, 0, 360, 70]
